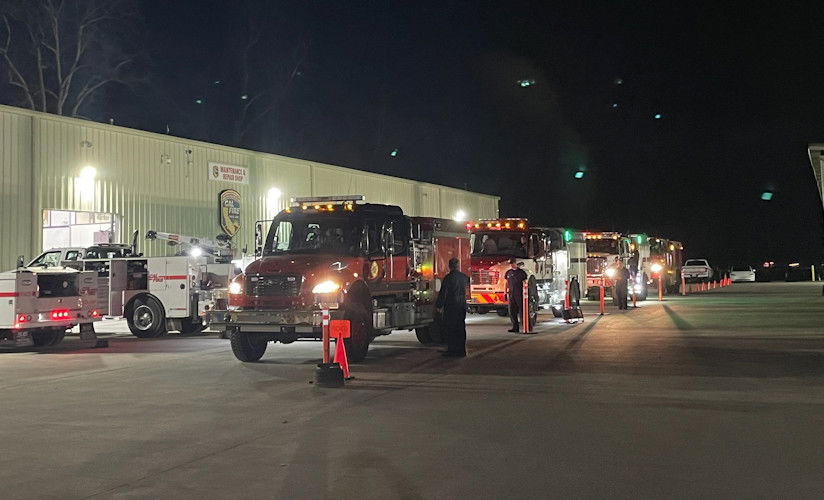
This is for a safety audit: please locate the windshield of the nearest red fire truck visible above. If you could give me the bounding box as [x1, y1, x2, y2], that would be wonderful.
[264, 213, 361, 255]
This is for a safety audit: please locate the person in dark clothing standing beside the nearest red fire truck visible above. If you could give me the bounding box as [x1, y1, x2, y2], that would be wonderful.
[435, 257, 469, 358]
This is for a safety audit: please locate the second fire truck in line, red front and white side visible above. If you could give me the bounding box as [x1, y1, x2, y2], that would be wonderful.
[466, 219, 586, 327]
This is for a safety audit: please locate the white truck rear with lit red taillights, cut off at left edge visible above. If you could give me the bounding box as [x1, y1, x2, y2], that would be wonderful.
[0, 267, 100, 347]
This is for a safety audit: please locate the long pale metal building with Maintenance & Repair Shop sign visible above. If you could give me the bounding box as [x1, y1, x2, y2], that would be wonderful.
[0, 106, 499, 270]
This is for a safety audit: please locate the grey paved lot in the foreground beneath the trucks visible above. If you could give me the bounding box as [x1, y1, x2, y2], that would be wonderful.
[0, 283, 824, 499]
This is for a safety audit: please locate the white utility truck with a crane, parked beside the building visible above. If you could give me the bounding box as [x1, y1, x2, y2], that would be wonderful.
[27, 231, 233, 338]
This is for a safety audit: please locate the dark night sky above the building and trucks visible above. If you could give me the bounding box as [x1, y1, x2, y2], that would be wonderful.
[3, 0, 824, 264]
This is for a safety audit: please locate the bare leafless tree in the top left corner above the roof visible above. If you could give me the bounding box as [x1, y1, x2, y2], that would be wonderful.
[0, 0, 134, 116]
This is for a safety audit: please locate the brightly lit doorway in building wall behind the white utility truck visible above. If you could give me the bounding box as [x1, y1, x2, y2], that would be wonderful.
[42, 210, 120, 251]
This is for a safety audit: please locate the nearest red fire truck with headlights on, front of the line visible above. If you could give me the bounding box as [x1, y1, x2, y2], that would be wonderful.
[209, 196, 470, 361]
